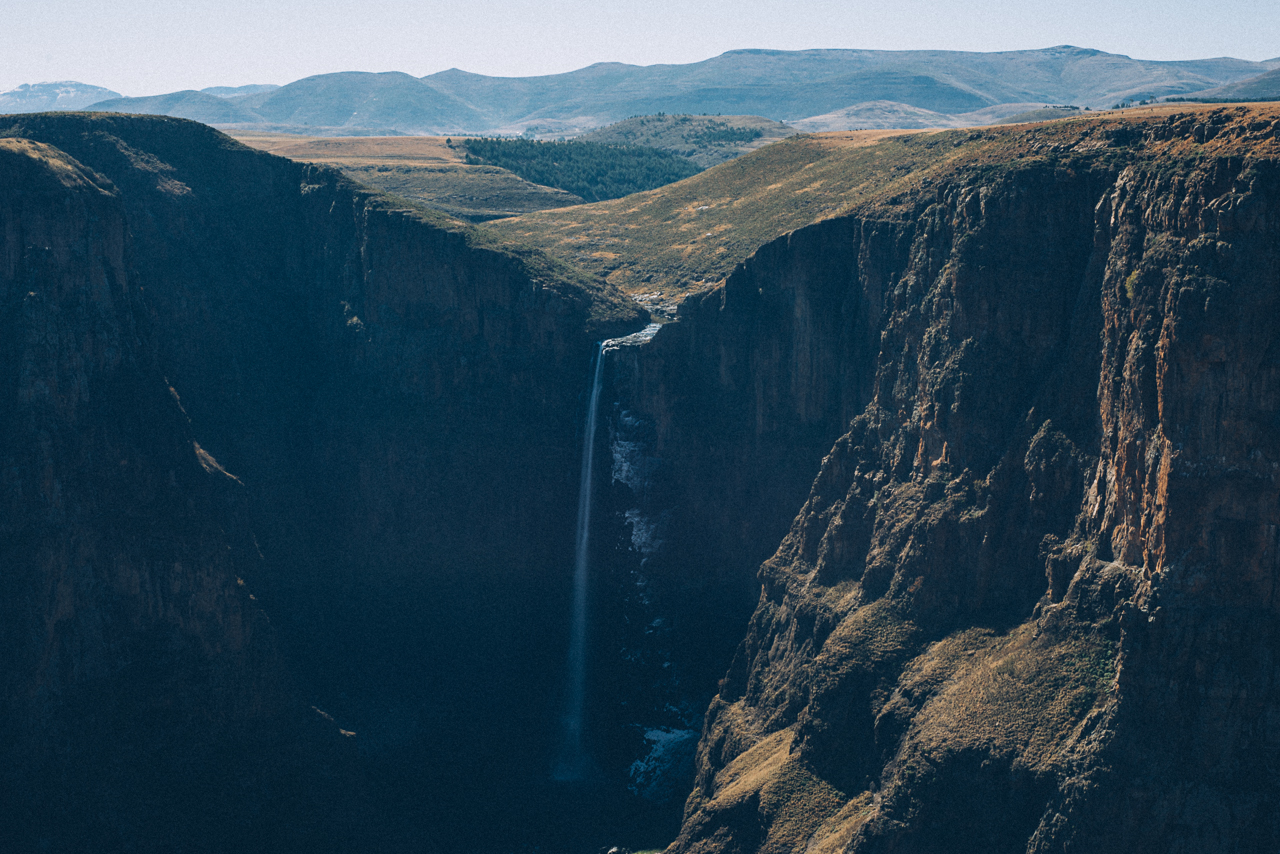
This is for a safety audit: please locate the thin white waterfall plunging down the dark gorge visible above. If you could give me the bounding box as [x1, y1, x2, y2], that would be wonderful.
[552, 342, 604, 781]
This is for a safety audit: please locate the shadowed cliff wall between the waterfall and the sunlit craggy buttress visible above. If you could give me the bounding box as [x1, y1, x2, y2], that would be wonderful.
[581, 220, 890, 814]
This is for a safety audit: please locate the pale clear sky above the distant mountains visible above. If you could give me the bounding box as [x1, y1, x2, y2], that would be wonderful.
[0, 0, 1280, 95]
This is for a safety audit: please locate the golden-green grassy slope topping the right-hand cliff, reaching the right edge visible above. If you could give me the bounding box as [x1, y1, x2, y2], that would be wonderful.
[493, 105, 1280, 300]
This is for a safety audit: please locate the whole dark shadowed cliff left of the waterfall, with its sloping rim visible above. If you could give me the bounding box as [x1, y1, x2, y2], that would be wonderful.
[0, 115, 643, 850]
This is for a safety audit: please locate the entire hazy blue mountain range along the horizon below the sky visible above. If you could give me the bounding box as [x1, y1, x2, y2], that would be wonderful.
[0, 46, 1280, 136]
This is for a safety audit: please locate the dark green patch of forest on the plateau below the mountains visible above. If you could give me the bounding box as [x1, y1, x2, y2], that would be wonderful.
[462, 138, 701, 202]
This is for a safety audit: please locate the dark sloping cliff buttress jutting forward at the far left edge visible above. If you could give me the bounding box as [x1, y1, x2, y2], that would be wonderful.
[0, 133, 371, 850]
